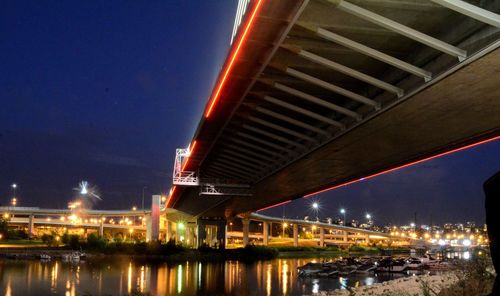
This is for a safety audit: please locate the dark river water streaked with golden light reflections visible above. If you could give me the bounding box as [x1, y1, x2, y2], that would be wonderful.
[0, 259, 414, 296]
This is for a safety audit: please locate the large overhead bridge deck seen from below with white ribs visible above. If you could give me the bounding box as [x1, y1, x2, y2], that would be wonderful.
[167, 0, 500, 235]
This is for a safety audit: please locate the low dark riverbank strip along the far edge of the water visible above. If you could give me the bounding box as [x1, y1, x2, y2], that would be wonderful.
[0, 243, 408, 262]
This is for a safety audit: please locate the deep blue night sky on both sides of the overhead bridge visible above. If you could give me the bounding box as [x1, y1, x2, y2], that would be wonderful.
[0, 0, 500, 224]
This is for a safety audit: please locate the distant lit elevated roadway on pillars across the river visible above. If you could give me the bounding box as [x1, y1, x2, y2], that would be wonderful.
[0, 205, 412, 247]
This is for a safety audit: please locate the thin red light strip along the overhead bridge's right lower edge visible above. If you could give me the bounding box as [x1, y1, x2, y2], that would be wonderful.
[257, 136, 500, 212]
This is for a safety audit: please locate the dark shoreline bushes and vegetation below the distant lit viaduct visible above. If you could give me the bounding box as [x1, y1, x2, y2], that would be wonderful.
[0, 234, 409, 262]
